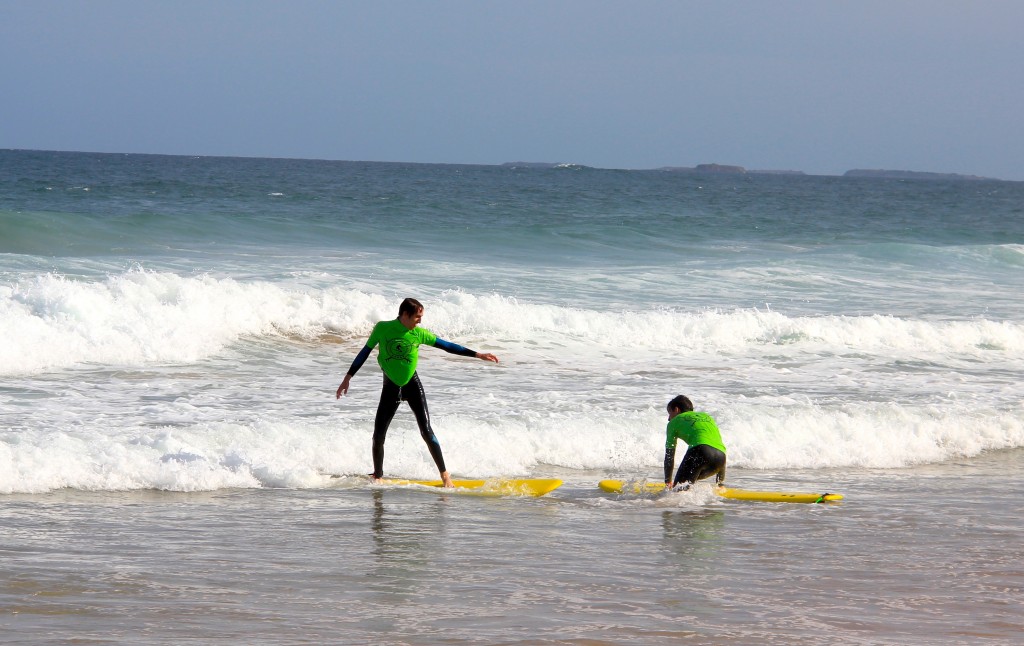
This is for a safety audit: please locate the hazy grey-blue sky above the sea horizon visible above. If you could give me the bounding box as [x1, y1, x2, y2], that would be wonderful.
[6, 0, 1024, 180]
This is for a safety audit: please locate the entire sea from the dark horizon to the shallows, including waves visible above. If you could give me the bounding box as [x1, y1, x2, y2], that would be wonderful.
[0, 150, 1024, 644]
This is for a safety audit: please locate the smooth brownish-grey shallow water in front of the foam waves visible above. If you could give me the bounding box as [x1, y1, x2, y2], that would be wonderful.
[0, 450, 1024, 644]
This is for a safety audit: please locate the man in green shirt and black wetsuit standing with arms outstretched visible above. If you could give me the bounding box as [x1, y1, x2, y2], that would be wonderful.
[336, 298, 498, 487]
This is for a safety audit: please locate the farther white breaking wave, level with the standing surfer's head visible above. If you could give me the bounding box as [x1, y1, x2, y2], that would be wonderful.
[0, 269, 1024, 375]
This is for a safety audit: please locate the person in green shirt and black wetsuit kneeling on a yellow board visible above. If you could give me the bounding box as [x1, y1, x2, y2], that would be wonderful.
[665, 395, 725, 489]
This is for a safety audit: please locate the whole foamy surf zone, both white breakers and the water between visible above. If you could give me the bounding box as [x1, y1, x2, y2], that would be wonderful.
[0, 269, 1024, 492]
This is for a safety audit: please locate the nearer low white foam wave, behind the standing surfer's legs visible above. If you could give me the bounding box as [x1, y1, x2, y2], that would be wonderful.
[0, 402, 1024, 493]
